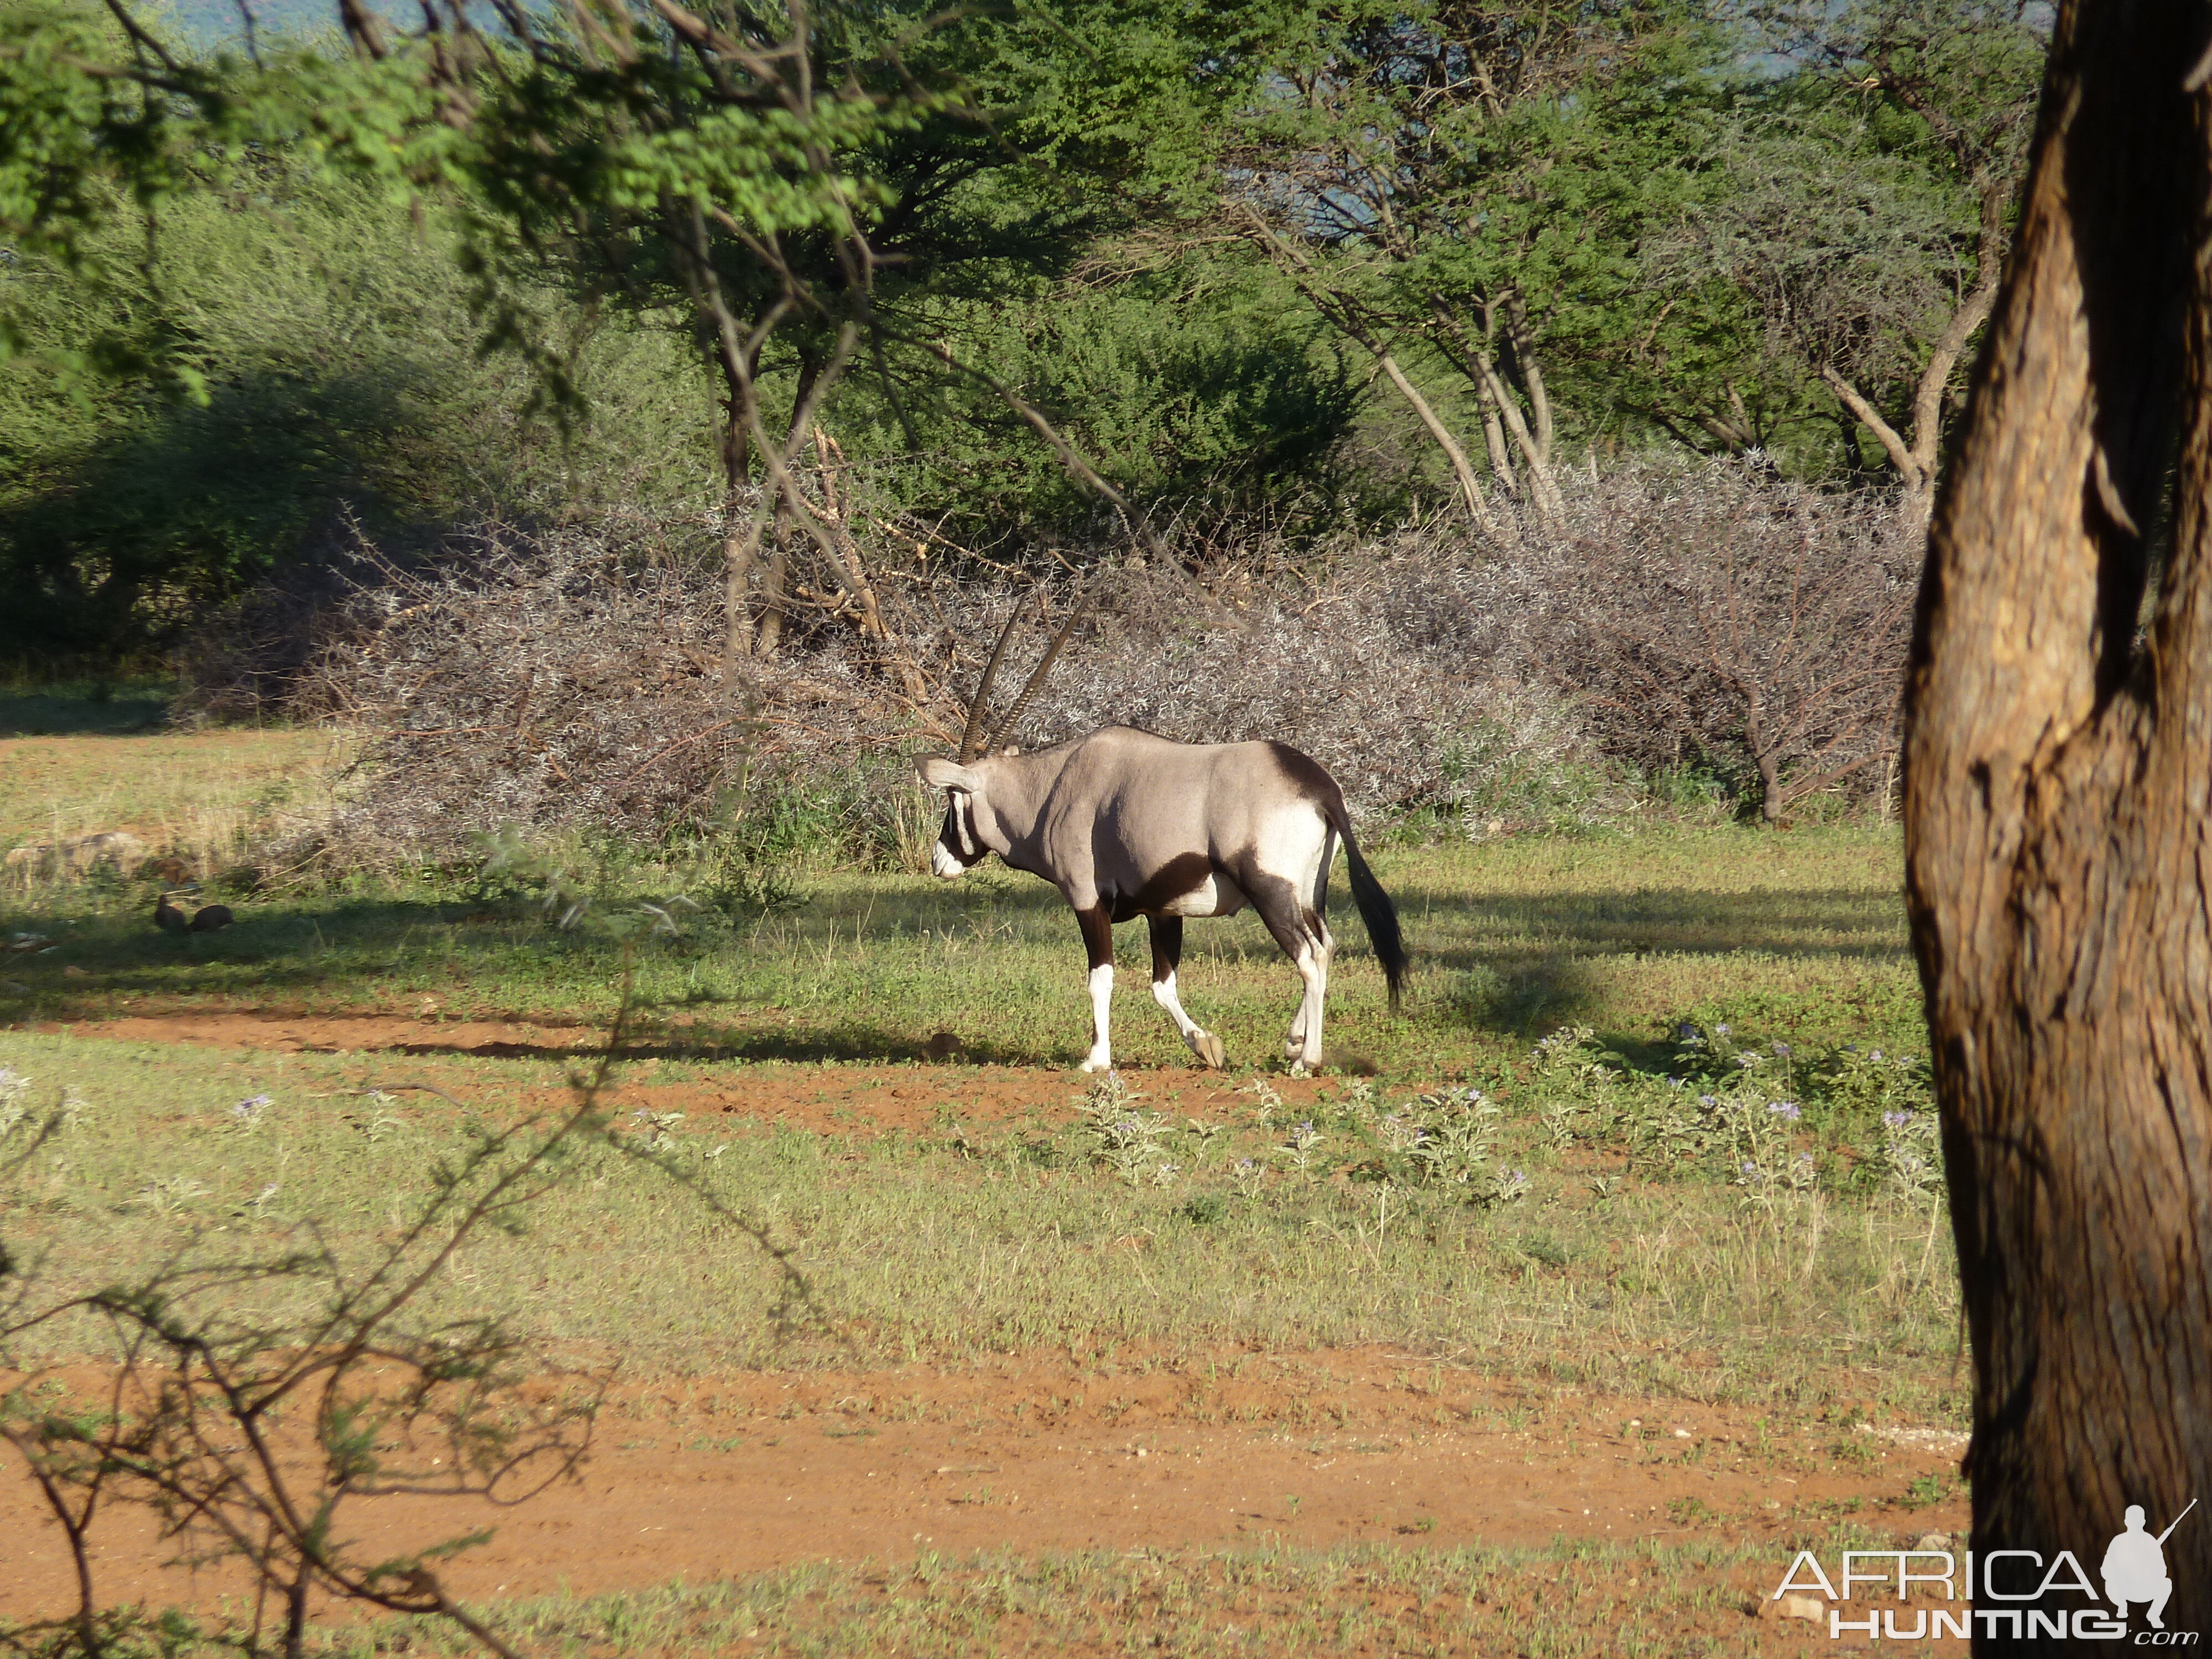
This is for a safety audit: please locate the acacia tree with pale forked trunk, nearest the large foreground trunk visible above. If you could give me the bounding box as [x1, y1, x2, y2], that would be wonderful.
[1681, 0, 2044, 531]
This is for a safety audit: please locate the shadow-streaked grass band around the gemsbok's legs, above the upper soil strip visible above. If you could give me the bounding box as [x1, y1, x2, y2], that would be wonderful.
[0, 825, 1920, 1082]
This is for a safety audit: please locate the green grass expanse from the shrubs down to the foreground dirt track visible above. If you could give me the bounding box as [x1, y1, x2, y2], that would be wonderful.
[0, 825, 1955, 1416]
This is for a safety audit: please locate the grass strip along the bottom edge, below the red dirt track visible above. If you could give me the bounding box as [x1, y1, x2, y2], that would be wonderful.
[74, 1531, 1920, 1659]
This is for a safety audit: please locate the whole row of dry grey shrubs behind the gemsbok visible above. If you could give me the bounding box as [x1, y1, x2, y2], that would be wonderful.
[229, 465, 1909, 863]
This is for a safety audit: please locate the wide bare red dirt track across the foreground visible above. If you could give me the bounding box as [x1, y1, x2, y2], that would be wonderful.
[0, 1349, 1966, 1641]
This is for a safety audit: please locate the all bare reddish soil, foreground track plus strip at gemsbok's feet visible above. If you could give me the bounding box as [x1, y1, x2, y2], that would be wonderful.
[0, 1006, 1969, 1652]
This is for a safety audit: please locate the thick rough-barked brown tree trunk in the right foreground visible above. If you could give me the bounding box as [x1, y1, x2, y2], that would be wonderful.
[1905, 0, 2212, 1652]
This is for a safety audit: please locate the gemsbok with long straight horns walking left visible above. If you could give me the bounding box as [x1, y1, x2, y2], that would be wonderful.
[916, 604, 1407, 1073]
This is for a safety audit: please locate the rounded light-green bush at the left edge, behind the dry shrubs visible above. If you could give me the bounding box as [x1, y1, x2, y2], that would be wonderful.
[0, 166, 706, 653]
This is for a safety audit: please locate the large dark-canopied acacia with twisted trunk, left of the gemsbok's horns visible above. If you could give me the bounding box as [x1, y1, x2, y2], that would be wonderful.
[0, 0, 1230, 672]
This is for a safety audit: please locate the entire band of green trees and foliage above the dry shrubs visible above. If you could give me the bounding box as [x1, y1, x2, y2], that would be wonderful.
[0, 0, 2044, 653]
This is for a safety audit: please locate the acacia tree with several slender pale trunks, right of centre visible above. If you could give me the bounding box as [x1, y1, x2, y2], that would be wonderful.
[1219, 0, 1725, 520]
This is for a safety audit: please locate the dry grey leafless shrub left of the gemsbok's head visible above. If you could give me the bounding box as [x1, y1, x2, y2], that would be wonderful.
[261, 520, 927, 860]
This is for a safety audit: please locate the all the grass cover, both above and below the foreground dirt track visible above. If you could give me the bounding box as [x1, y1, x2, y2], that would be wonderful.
[0, 734, 1964, 1659]
